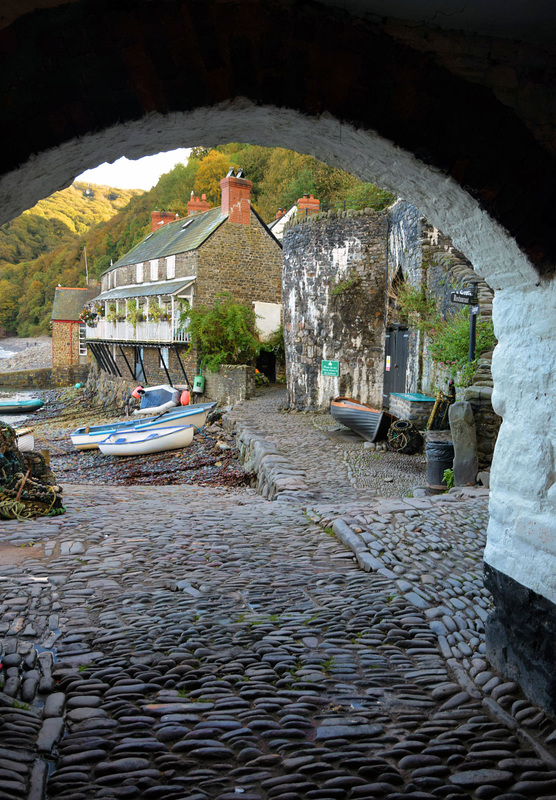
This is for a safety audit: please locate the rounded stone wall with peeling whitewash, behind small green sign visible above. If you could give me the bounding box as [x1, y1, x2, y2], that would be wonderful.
[282, 209, 387, 409]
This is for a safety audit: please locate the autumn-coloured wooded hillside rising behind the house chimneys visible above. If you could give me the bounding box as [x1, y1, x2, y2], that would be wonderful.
[0, 144, 393, 336]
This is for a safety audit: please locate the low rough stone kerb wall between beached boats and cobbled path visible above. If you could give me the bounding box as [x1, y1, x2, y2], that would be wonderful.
[222, 415, 314, 501]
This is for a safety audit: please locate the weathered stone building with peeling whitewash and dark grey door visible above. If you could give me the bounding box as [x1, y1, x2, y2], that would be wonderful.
[282, 201, 500, 467]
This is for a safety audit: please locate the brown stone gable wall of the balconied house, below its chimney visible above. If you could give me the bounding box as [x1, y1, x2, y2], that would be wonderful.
[195, 211, 282, 306]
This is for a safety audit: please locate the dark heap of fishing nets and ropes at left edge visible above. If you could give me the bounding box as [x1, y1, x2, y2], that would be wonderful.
[0, 423, 66, 519]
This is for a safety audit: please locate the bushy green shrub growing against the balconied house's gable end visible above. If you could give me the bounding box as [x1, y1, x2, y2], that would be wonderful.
[180, 292, 261, 372]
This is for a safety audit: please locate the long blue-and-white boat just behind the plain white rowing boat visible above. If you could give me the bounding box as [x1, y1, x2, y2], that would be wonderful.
[70, 403, 216, 450]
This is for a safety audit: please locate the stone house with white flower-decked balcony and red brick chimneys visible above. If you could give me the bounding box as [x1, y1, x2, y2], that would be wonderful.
[87, 174, 282, 385]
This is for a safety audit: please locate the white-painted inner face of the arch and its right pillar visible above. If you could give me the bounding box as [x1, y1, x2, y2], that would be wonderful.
[0, 98, 556, 600]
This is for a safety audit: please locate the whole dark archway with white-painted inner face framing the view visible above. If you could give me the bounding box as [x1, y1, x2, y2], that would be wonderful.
[0, 0, 556, 710]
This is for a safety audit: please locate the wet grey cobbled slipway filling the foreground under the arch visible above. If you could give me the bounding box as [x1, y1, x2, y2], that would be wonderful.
[0, 393, 556, 800]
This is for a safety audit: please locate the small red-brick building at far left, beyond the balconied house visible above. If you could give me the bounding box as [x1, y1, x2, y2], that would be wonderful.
[51, 285, 99, 367]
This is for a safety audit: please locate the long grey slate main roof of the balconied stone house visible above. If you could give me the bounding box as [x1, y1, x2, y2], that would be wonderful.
[103, 207, 228, 274]
